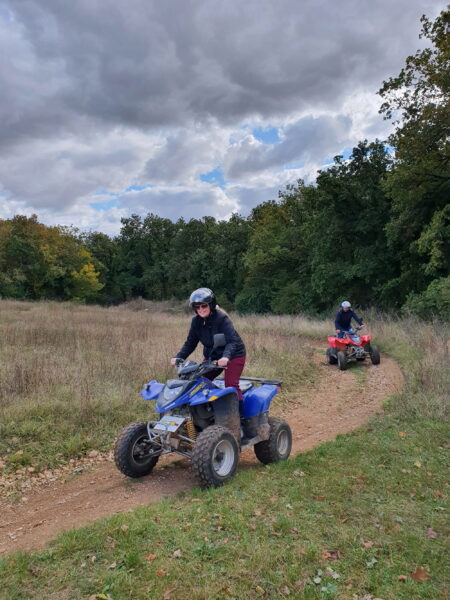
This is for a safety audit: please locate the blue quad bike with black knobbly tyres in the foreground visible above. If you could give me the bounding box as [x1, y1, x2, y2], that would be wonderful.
[114, 334, 292, 487]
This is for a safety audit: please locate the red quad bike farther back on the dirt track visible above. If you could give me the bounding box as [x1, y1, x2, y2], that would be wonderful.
[327, 327, 380, 371]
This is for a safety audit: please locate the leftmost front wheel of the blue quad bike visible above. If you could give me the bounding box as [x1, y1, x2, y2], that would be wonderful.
[114, 422, 159, 478]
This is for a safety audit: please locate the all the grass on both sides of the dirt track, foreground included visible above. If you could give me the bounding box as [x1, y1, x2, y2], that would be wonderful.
[0, 302, 449, 600]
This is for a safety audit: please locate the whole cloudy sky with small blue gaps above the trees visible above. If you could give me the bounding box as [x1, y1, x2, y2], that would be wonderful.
[0, 0, 446, 235]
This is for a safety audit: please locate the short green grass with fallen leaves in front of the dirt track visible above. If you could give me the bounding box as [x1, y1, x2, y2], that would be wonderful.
[0, 417, 447, 600]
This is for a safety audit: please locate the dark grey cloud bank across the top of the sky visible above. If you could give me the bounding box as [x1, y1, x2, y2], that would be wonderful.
[1, 0, 442, 135]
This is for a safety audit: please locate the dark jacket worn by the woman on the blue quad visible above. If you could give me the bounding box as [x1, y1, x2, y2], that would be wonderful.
[177, 309, 245, 360]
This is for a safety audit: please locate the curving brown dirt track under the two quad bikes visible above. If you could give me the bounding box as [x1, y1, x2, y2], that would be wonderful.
[0, 352, 403, 555]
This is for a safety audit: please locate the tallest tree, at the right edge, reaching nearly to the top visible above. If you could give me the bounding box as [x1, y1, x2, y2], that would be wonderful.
[379, 10, 450, 304]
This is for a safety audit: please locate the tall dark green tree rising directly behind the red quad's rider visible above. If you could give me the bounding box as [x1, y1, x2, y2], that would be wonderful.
[303, 140, 392, 310]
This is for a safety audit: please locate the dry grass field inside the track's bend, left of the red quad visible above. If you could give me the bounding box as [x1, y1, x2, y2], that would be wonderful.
[0, 301, 313, 468]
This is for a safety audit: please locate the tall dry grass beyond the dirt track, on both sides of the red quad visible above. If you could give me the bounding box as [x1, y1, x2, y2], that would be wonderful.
[0, 301, 449, 468]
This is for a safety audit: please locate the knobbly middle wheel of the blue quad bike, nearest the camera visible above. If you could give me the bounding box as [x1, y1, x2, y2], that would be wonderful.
[192, 425, 239, 487]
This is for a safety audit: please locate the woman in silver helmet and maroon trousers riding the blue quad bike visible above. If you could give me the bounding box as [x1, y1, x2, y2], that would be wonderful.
[170, 288, 245, 400]
